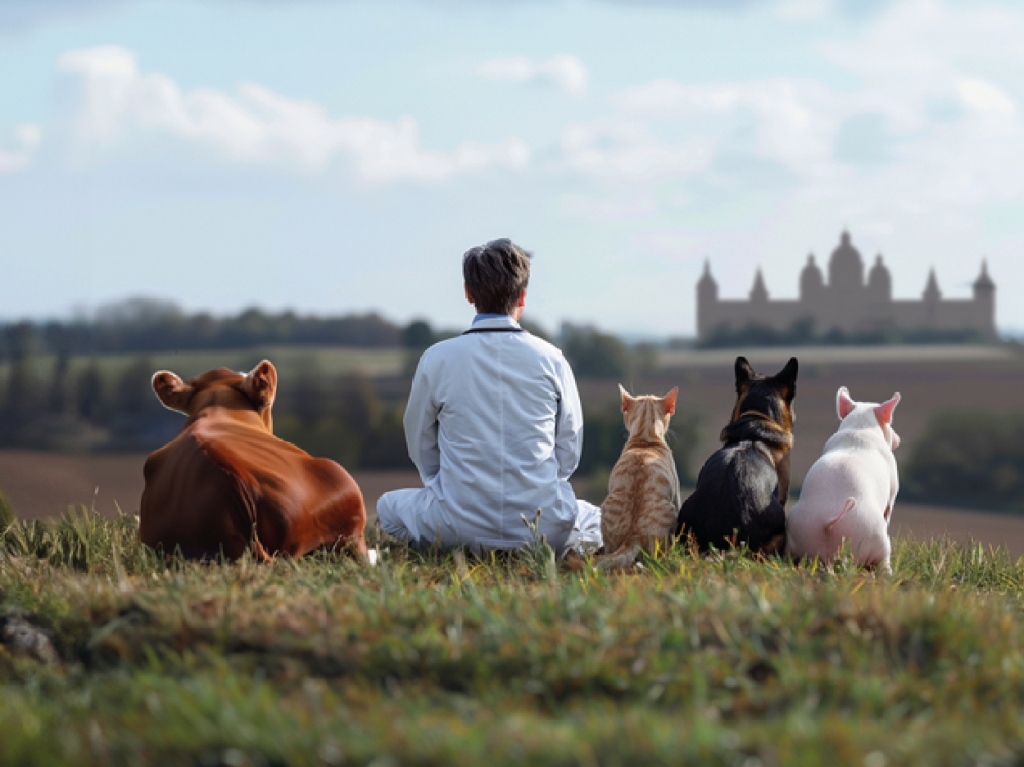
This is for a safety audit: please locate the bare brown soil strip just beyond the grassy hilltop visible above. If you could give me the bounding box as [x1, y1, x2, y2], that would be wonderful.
[0, 451, 1024, 556]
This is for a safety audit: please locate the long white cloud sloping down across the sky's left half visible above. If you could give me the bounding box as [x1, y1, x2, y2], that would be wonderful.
[58, 46, 529, 182]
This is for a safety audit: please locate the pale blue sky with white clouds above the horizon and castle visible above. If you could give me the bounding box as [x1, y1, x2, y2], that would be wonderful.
[0, 0, 1024, 335]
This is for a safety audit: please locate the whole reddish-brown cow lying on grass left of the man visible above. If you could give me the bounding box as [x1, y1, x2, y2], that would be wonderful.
[139, 359, 367, 560]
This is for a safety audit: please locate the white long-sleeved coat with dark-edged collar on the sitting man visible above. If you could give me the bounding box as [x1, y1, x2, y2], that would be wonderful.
[404, 316, 583, 548]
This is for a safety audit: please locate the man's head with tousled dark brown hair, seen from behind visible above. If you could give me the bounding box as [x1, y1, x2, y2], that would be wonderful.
[462, 238, 529, 314]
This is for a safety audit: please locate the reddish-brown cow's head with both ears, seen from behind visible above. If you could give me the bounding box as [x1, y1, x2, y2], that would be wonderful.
[153, 359, 278, 431]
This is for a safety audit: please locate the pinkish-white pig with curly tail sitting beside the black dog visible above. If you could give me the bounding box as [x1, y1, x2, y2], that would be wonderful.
[785, 386, 900, 572]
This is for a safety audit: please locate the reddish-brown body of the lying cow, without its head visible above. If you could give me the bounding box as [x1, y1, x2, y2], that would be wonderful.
[140, 414, 366, 558]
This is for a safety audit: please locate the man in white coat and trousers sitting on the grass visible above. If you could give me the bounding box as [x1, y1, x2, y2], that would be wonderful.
[377, 240, 601, 553]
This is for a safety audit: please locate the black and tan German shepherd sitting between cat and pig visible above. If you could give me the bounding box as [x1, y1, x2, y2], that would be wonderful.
[676, 357, 798, 554]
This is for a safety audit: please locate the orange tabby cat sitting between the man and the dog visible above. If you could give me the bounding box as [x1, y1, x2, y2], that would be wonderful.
[597, 386, 680, 569]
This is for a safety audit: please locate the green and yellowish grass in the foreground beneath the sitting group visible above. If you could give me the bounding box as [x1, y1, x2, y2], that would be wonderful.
[0, 511, 1024, 767]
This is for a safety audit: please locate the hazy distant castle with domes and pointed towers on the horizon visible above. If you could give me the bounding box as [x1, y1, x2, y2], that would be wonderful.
[697, 231, 997, 341]
